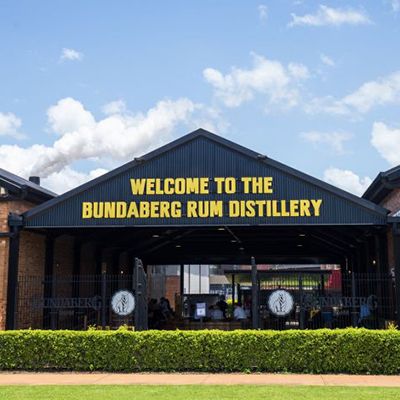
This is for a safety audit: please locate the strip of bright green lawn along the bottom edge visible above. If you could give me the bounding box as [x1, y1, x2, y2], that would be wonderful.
[0, 385, 400, 400]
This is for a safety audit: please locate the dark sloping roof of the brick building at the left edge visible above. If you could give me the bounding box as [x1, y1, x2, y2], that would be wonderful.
[0, 168, 57, 203]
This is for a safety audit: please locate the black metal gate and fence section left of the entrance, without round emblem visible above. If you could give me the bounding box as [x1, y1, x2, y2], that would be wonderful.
[15, 258, 147, 330]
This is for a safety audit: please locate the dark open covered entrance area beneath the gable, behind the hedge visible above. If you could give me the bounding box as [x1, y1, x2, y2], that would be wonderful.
[12, 225, 395, 329]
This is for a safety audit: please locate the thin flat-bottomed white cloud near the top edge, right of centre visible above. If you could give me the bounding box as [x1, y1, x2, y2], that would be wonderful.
[288, 5, 371, 27]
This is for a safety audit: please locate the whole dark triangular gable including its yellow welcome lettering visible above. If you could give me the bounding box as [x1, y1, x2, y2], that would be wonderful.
[24, 133, 386, 227]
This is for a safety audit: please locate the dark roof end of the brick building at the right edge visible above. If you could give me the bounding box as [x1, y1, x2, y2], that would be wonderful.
[362, 165, 400, 204]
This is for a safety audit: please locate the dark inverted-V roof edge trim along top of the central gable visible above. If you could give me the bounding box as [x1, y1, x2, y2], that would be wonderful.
[24, 129, 388, 219]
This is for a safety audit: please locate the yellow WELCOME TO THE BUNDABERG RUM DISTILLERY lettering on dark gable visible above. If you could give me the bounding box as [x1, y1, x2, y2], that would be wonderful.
[81, 176, 323, 220]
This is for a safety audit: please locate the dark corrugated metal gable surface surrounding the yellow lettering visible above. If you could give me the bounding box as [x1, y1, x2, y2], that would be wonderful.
[24, 129, 387, 227]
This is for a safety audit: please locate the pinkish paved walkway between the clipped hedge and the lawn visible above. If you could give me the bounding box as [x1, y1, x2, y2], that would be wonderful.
[0, 372, 400, 387]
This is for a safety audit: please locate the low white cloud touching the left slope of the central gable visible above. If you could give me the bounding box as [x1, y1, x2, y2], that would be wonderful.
[41, 166, 108, 194]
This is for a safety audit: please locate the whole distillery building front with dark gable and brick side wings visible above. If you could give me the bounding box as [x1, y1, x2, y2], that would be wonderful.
[0, 130, 400, 329]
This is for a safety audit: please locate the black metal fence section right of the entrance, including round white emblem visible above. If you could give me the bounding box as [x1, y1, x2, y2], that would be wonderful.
[250, 270, 396, 329]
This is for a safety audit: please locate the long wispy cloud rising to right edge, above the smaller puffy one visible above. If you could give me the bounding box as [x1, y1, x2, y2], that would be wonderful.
[306, 71, 400, 115]
